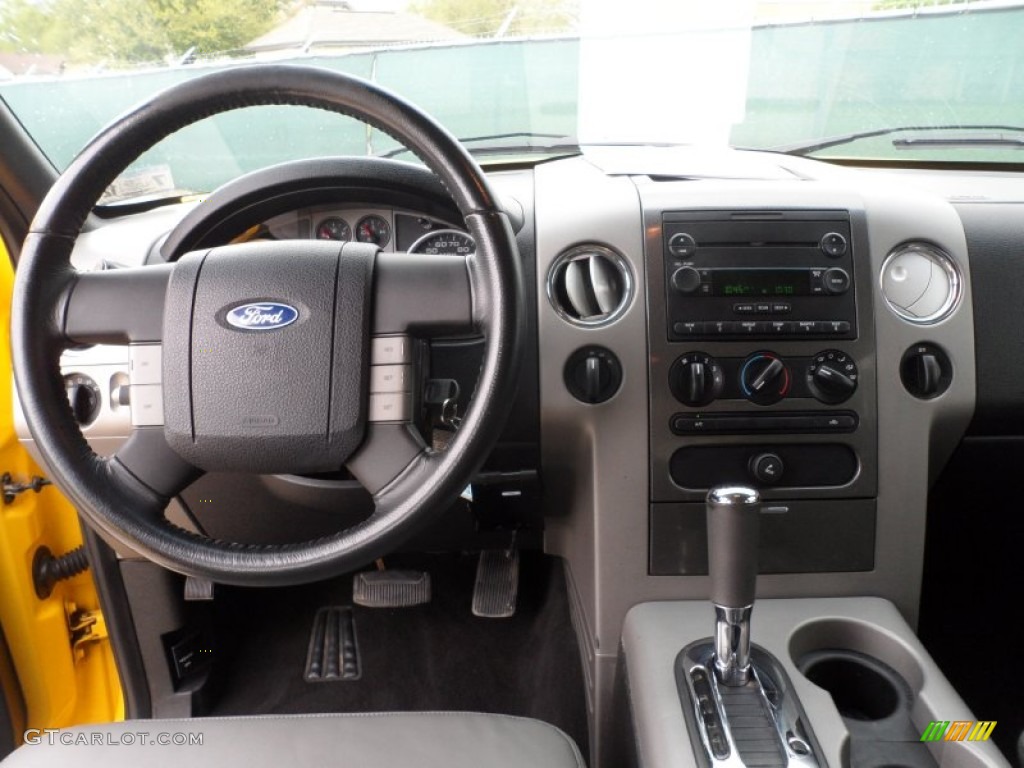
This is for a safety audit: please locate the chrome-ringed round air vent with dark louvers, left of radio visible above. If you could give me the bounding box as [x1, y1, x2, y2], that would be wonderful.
[548, 245, 633, 328]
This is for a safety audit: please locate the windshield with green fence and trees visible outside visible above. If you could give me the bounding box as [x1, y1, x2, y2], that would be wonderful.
[0, 0, 1024, 201]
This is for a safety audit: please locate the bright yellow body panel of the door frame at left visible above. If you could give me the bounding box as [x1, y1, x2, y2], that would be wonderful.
[0, 242, 124, 735]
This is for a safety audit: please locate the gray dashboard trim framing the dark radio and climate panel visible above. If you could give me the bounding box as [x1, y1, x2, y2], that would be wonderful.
[535, 158, 975, 765]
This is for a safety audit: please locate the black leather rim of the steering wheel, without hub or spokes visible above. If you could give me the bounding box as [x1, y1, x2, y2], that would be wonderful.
[11, 65, 523, 586]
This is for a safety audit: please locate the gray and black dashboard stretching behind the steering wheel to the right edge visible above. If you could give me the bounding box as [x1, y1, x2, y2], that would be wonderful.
[17, 147, 1024, 716]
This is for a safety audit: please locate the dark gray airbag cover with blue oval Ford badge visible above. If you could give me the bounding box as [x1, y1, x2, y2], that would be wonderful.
[163, 243, 377, 473]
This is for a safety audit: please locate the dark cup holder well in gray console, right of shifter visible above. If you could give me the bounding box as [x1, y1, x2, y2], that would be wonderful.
[798, 650, 909, 721]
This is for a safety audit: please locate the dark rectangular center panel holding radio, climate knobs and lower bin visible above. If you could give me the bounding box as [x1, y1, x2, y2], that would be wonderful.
[645, 208, 878, 575]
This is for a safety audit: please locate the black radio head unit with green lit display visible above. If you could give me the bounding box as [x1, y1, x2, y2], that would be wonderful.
[663, 211, 857, 341]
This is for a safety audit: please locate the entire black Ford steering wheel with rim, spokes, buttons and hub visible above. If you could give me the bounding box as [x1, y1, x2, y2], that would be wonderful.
[11, 65, 523, 586]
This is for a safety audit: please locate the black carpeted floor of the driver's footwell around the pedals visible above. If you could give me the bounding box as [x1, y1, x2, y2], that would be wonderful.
[207, 553, 588, 765]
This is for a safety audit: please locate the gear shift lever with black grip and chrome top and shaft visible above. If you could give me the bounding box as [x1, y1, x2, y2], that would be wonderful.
[707, 485, 761, 686]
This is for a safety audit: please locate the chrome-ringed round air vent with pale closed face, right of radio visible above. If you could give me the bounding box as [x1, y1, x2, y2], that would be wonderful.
[882, 243, 963, 325]
